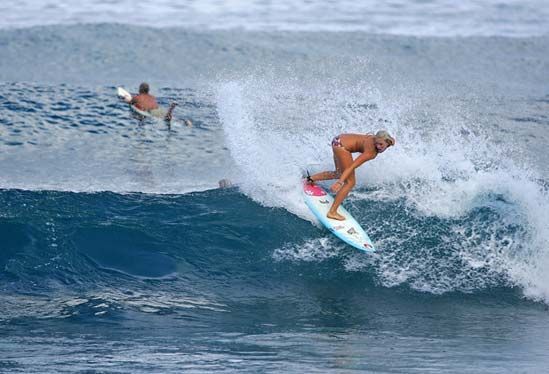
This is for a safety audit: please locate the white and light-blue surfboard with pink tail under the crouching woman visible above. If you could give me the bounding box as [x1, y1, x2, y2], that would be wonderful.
[303, 183, 375, 252]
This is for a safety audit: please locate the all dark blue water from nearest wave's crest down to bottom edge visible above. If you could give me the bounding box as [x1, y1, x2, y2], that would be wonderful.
[0, 188, 549, 373]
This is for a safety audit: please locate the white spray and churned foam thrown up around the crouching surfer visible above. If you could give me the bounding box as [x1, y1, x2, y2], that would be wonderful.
[217, 76, 549, 303]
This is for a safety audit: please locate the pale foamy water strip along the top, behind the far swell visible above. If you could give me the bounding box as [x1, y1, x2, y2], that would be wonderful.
[0, 0, 549, 37]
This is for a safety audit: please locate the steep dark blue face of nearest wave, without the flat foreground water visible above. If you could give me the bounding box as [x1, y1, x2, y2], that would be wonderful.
[0, 188, 547, 306]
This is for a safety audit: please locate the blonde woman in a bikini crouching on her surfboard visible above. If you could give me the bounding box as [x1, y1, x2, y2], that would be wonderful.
[307, 130, 395, 221]
